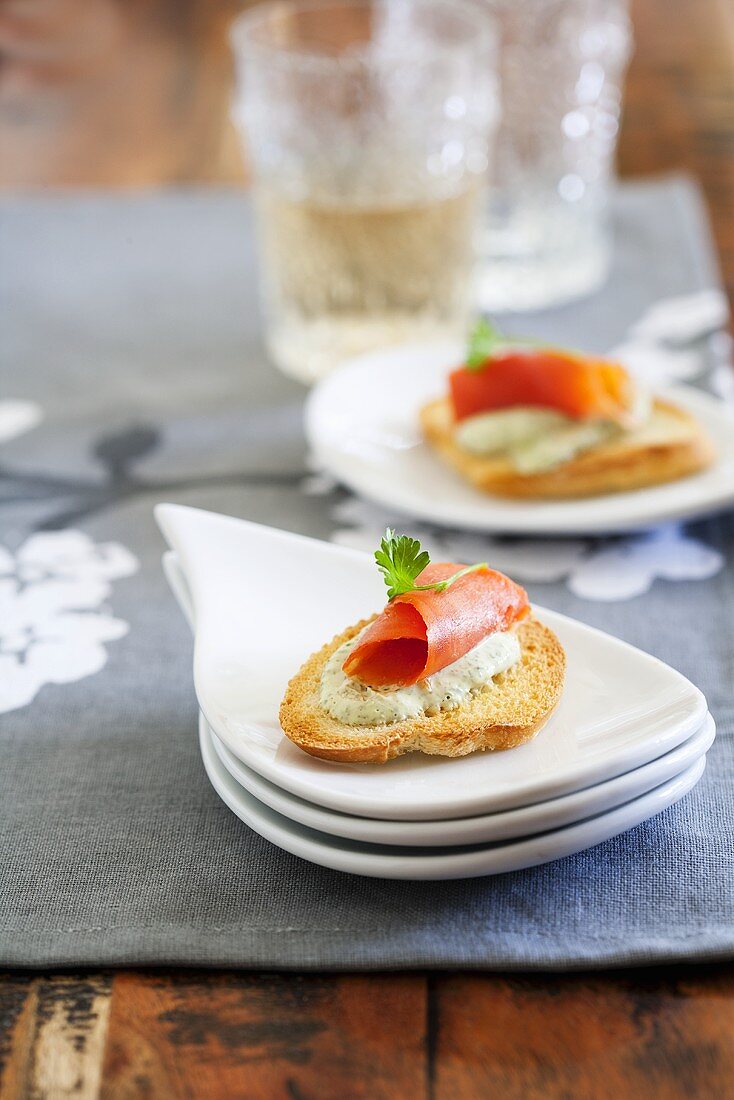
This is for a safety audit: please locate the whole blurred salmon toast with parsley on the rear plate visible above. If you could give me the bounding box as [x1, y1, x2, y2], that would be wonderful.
[420, 321, 714, 499]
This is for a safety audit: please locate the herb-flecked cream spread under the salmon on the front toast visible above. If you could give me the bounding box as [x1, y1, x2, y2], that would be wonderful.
[319, 627, 521, 726]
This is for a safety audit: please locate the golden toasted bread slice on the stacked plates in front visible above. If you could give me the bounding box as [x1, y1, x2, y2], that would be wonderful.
[281, 615, 566, 763]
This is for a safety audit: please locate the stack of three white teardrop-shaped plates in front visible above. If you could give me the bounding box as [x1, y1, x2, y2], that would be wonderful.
[157, 505, 714, 879]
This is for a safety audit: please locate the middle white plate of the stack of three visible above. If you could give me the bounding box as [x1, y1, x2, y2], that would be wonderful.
[201, 714, 716, 847]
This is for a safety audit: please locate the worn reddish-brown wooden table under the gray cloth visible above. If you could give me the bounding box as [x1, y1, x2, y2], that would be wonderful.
[0, 0, 734, 1100]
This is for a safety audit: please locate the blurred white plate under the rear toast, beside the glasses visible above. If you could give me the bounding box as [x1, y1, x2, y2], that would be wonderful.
[306, 345, 734, 535]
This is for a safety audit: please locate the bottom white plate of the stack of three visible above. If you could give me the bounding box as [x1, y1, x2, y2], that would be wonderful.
[199, 718, 705, 879]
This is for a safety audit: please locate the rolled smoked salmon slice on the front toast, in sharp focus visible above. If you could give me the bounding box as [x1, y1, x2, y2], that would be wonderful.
[342, 562, 529, 688]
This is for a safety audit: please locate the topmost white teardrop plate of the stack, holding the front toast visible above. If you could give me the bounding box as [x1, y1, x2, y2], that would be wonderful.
[156, 505, 708, 821]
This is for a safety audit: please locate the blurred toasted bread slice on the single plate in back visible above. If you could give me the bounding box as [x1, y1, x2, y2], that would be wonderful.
[420, 398, 714, 499]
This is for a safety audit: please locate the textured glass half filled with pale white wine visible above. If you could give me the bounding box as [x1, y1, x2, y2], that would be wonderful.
[232, 0, 497, 382]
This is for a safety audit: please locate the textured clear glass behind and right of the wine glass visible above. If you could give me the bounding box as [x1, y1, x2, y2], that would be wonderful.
[478, 0, 632, 311]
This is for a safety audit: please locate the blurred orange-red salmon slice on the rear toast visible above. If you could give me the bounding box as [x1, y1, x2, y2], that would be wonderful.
[450, 349, 632, 420]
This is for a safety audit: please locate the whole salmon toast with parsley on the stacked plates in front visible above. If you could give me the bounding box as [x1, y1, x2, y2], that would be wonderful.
[281, 530, 566, 763]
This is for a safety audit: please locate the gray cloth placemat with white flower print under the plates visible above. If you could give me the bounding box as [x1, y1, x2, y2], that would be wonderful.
[0, 180, 734, 968]
